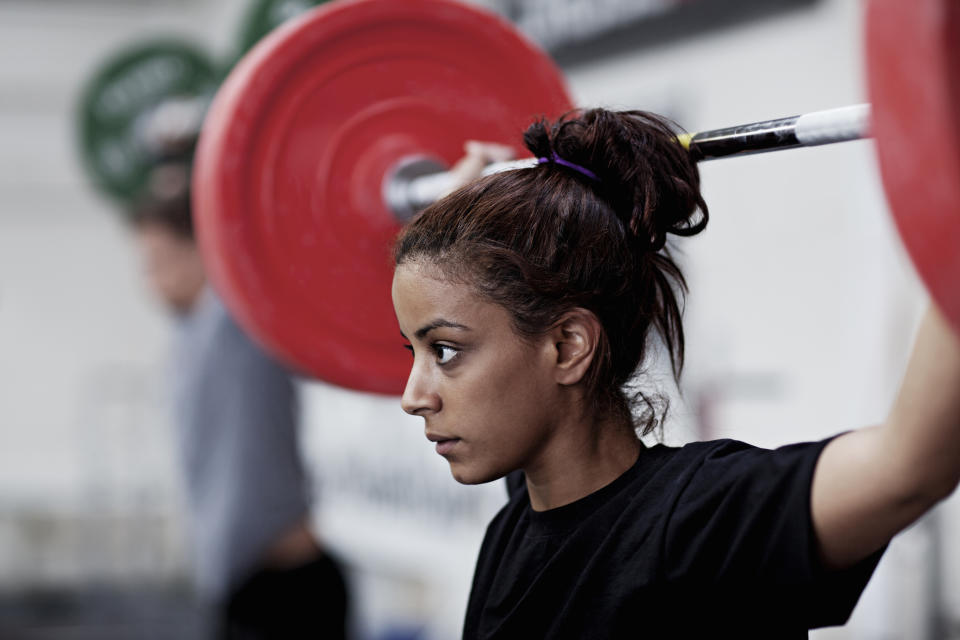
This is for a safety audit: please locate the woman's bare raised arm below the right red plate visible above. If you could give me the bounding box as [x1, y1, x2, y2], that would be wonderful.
[811, 304, 960, 569]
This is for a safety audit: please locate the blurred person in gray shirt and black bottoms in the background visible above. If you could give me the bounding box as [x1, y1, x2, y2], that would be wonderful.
[131, 165, 348, 639]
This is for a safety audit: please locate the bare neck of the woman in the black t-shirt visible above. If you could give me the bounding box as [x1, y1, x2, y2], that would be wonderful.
[524, 412, 643, 511]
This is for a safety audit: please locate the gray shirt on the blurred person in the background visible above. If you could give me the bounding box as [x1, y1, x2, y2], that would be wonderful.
[173, 291, 308, 603]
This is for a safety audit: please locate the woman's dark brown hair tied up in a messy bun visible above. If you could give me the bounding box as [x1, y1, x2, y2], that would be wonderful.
[394, 109, 708, 433]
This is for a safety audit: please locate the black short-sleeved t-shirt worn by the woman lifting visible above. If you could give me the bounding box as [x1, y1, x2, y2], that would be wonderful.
[463, 440, 883, 640]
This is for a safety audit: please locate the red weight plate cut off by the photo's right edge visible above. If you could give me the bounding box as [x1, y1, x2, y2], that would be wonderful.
[867, 0, 960, 330]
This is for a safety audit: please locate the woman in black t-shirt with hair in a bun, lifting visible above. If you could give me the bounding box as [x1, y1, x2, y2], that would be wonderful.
[393, 109, 960, 638]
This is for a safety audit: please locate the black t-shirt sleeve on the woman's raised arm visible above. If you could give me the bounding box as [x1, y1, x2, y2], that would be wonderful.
[663, 440, 883, 628]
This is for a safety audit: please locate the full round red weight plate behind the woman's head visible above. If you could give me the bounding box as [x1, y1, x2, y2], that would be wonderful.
[193, 0, 571, 394]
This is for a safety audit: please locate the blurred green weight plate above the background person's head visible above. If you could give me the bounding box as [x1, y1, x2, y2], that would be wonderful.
[78, 40, 217, 202]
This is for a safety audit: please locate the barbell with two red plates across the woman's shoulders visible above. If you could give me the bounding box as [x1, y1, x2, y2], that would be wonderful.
[193, 0, 960, 393]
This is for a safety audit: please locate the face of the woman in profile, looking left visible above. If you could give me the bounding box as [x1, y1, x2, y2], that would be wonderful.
[393, 262, 560, 484]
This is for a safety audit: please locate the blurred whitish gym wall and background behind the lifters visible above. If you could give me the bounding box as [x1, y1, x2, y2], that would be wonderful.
[0, 0, 960, 640]
